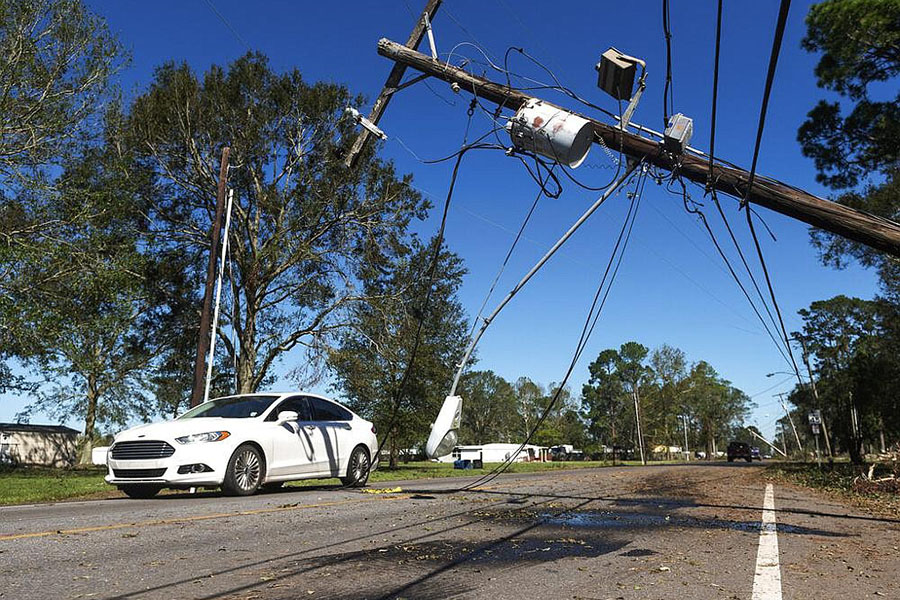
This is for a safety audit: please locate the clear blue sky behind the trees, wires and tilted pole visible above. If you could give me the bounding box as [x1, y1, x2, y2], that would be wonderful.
[0, 0, 876, 434]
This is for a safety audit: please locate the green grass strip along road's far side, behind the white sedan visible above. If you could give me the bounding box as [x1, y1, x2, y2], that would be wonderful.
[0, 461, 677, 506]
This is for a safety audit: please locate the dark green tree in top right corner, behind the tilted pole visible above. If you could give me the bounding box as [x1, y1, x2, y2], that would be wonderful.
[798, 0, 900, 288]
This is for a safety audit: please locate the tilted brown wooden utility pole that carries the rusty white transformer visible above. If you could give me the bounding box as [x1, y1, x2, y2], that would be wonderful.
[374, 37, 900, 257]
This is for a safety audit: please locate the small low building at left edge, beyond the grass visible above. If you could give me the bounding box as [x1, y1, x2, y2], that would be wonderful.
[0, 423, 79, 468]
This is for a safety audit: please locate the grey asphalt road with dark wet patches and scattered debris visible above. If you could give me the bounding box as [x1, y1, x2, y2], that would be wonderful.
[0, 463, 900, 600]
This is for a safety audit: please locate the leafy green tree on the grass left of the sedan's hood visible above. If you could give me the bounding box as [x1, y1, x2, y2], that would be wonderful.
[7, 142, 157, 462]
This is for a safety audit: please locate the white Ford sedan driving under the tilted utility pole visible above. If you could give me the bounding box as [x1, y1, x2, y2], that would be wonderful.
[106, 392, 378, 498]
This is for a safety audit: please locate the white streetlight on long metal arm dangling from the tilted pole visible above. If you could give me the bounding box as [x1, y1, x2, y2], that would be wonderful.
[425, 162, 641, 458]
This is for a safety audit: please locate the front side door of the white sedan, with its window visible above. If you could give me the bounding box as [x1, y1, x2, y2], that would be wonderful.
[266, 396, 324, 477]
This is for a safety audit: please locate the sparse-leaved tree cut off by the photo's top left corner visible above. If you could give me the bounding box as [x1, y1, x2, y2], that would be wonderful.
[0, 0, 121, 412]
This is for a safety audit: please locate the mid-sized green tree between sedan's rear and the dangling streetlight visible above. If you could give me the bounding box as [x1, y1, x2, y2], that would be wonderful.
[328, 239, 468, 467]
